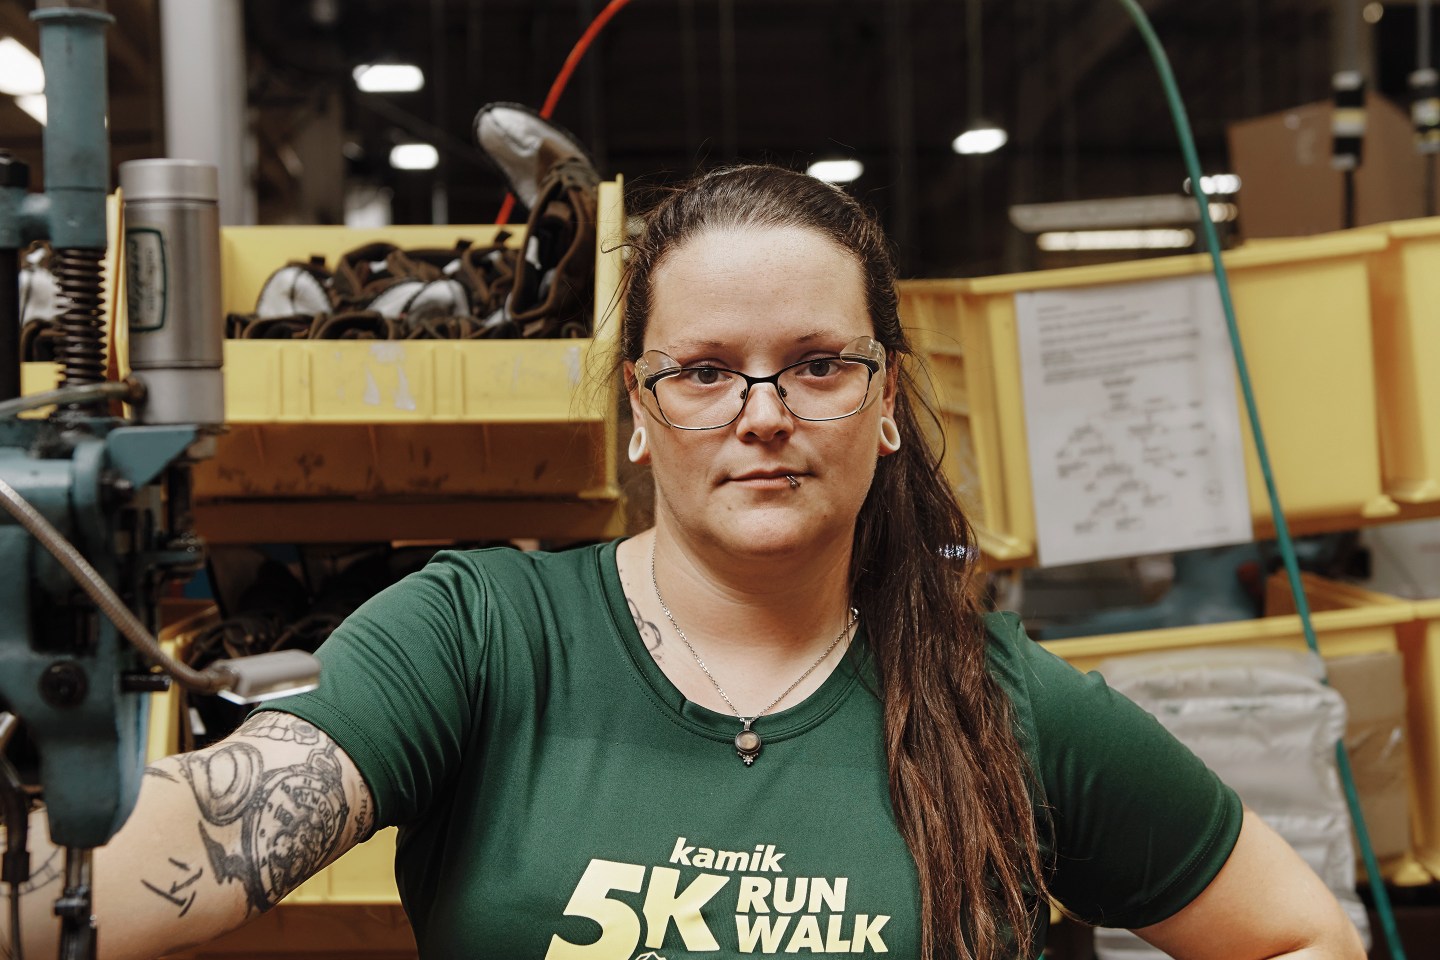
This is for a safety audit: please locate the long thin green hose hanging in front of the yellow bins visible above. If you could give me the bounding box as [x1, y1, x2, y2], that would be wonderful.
[1120, 0, 1405, 960]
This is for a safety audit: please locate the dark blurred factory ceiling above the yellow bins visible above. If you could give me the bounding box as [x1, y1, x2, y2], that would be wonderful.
[0, 0, 1416, 275]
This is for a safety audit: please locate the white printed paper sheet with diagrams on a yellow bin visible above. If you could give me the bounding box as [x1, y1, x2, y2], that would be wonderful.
[1015, 276, 1253, 566]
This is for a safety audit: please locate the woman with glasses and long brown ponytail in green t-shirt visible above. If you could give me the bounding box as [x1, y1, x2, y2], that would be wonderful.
[5, 167, 1362, 960]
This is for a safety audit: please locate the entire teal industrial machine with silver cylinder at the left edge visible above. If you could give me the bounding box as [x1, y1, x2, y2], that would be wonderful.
[0, 0, 318, 960]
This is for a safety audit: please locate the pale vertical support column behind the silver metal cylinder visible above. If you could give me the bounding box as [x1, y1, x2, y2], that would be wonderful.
[160, 0, 255, 226]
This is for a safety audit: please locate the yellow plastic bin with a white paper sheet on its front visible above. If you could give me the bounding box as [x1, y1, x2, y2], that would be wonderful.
[900, 232, 1398, 563]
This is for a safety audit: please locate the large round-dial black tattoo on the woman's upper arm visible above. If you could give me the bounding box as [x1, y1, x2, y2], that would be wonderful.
[180, 741, 350, 913]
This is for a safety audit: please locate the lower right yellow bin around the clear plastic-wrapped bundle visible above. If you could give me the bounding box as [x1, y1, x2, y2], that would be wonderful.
[1041, 577, 1440, 885]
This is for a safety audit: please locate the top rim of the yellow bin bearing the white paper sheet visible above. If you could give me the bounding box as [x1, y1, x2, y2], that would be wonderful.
[949, 232, 1390, 295]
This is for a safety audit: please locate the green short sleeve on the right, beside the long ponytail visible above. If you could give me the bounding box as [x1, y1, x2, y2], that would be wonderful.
[988, 615, 1244, 928]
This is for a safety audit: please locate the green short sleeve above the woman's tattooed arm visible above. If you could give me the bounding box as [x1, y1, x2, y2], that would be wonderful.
[256, 554, 487, 826]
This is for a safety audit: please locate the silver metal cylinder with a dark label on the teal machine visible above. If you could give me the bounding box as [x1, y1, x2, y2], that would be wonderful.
[120, 160, 225, 423]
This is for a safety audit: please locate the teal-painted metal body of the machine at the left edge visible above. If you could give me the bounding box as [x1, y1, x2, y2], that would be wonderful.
[0, 417, 206, 848]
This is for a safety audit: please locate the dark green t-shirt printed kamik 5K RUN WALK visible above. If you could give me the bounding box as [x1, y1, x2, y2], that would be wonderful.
[264, 543, 1241, 960]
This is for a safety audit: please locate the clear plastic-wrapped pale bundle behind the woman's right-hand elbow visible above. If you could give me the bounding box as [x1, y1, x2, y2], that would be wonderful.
[1096, 648, 1369, 960]
